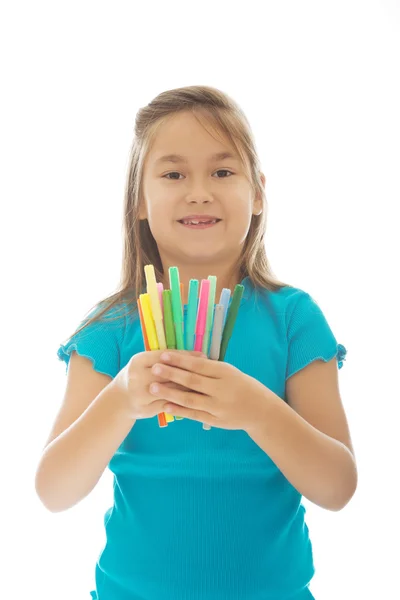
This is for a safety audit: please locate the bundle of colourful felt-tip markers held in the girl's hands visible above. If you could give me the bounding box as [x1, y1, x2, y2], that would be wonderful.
[137, 265, 244, 429]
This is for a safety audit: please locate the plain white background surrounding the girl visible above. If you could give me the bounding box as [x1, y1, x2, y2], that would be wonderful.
[0, 0, 400, 600]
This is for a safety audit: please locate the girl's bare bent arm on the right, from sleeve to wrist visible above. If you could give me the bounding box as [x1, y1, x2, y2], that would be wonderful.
[246, 359, 357, 511]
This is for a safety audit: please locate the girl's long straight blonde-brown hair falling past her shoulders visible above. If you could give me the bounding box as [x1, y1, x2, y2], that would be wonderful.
[63, 85, 292, 339]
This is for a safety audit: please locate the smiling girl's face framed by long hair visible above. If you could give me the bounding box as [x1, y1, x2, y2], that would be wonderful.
[140, 113, 264, 265]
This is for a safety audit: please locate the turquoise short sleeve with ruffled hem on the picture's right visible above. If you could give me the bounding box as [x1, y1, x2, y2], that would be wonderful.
[286, 291, 347, 379]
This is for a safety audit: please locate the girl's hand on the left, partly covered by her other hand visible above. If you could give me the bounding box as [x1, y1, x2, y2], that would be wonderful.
[110, 350, 205, 420]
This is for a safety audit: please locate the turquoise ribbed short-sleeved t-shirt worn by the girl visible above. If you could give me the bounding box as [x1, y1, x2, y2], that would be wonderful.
[58, 277, 347, 600]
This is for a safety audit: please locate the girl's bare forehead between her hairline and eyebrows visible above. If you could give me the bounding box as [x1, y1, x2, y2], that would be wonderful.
[149, 113, 240, 164]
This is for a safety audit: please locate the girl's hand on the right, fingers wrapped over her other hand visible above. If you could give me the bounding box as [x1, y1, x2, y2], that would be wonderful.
[150, 350, 272, 431]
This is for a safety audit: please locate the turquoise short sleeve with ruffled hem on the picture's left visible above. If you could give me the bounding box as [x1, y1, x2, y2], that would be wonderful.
[57, 306, 125, 378]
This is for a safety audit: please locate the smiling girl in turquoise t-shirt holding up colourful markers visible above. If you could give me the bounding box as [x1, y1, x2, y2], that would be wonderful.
[36, 86, 357, 600]
